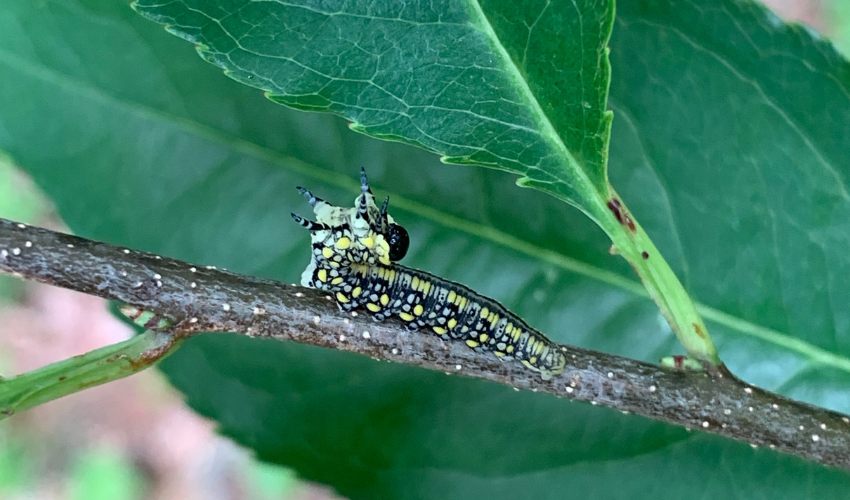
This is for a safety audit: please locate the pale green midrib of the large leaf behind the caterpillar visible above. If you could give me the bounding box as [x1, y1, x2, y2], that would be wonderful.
[0, 49, 850, 373]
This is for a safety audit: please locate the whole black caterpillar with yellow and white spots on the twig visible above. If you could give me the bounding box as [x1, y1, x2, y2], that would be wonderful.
[292, 168, 566, 380]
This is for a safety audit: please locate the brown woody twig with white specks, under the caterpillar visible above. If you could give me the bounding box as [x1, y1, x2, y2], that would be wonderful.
[0, 219, 850, 470]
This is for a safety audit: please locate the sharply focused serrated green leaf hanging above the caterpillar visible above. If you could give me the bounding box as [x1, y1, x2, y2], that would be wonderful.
[133, 0, 613, 214]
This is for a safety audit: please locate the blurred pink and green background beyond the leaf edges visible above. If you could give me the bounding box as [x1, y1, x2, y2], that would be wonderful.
[0, 0, 850, 500]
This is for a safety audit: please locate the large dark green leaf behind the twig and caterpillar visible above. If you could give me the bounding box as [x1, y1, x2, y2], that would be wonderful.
[0, 0, 850, 498]
